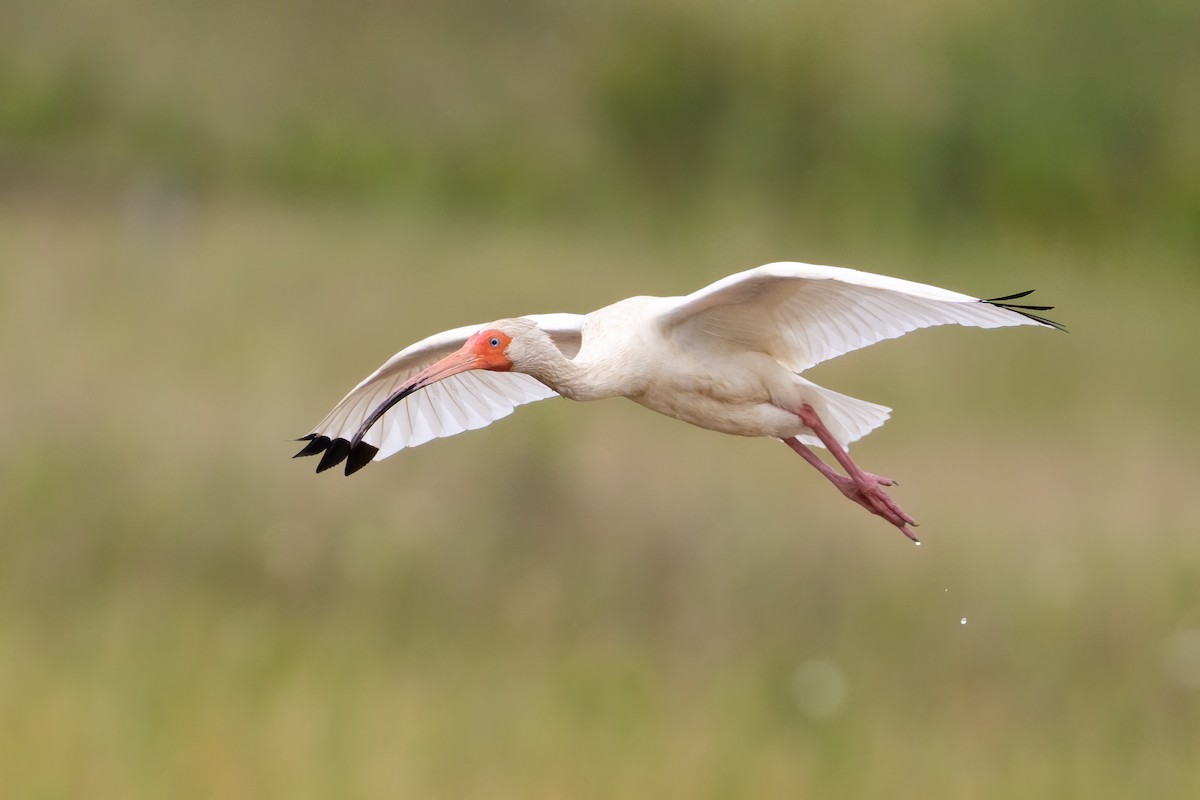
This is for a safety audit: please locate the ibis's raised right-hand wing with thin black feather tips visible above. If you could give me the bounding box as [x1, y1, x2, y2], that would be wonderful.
[659, 261, 1064, 372]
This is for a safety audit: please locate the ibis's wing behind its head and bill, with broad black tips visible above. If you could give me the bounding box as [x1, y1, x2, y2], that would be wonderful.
[296, 314, 583, 475]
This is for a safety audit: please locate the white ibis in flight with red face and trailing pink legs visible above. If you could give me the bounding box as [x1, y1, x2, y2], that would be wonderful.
[296, 263, 1066, 541]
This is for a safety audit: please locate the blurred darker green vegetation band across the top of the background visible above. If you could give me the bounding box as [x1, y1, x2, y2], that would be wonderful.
[0, 0, 1200, 237]
